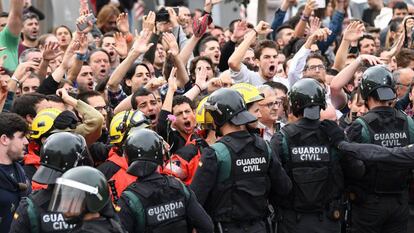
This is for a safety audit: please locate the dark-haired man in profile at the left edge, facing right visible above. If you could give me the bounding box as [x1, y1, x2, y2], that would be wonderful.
[0, 113, 31, 233]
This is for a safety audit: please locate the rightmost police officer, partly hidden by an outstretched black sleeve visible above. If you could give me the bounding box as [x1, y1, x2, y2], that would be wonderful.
[347, 66, 414, 232]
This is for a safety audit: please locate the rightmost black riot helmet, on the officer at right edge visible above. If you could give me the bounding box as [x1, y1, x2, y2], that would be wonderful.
[359, 65, 396, 101]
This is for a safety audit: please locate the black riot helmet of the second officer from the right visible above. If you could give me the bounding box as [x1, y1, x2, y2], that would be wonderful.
[288, 78, 326, 120]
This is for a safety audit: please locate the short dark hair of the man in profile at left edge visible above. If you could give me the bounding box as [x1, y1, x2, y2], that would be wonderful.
[0, 112, 28, 138]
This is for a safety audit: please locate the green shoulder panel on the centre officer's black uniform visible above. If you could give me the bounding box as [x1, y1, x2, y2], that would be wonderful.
[210, 142, 231, 182]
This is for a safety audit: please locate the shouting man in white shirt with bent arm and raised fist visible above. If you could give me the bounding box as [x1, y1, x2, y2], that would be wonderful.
[228, 21, 279, 86]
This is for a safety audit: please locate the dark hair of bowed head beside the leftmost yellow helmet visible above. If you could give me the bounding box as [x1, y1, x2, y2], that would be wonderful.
[11, 93, 47, 118]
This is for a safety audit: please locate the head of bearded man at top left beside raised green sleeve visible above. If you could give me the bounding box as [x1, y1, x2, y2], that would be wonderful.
[19, 13, 39, 55]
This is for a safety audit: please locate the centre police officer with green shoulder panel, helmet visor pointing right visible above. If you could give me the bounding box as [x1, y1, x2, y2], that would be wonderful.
[191, 88, 292, 232]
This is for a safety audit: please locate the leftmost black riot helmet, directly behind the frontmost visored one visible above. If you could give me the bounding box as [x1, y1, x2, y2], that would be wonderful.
[33, 132, 88, 184]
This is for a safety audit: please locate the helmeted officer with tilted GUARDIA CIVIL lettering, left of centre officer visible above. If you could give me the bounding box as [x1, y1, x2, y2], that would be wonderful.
[119, 129, 213, 233]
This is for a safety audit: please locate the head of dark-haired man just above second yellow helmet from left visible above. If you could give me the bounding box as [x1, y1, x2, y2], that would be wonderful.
[131, 87, 160, 129]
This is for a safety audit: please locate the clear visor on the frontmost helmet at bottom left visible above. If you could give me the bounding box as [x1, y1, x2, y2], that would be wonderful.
[49, 178, 102, 217]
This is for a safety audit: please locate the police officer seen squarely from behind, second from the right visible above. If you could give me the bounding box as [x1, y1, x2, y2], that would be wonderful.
[271, 78, 362, 233]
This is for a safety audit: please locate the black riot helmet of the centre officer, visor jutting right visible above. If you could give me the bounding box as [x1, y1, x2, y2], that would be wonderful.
[204, 88, 257, 127]
